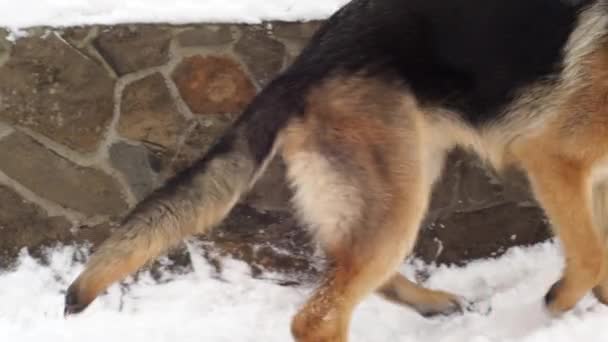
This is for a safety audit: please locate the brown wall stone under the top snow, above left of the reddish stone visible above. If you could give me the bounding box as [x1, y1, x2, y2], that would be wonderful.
[94, 25, 171, 76]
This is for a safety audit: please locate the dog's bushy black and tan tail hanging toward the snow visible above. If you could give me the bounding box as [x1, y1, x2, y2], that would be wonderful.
[65, 79, 301, 315]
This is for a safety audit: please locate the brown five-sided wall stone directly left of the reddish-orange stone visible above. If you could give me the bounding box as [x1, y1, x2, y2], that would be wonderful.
[117, 73, 187, 151]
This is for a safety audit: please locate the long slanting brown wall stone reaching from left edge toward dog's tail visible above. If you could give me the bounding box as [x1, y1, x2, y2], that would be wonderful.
[0, 132, 127, 215]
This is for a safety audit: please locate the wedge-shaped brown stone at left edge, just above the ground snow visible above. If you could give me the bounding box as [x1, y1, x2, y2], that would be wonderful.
[0, 185, 72, 266]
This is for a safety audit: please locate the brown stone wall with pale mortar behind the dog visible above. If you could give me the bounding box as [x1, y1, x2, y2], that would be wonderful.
[0, 22, 548, 270]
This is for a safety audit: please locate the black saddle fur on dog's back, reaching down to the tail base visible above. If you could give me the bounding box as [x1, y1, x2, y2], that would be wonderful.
[238, 0, 595, 161]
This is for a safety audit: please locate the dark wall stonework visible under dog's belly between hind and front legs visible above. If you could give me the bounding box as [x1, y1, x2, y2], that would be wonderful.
[416, 150, 551, 264]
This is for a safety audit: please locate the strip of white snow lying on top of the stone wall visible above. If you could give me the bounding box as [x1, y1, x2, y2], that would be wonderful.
[0, 0, 348, 31]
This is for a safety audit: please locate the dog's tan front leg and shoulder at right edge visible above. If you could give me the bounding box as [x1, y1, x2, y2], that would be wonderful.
[506, 43, 608, 313]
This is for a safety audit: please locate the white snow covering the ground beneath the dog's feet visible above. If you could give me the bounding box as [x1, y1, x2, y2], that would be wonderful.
[0, 243, 608, 342]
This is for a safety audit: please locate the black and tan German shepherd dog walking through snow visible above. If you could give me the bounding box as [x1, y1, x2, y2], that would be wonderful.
[65, 0, 608, 342]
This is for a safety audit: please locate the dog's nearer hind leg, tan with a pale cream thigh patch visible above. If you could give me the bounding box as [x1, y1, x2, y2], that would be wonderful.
[282, 79, 452, 342]
